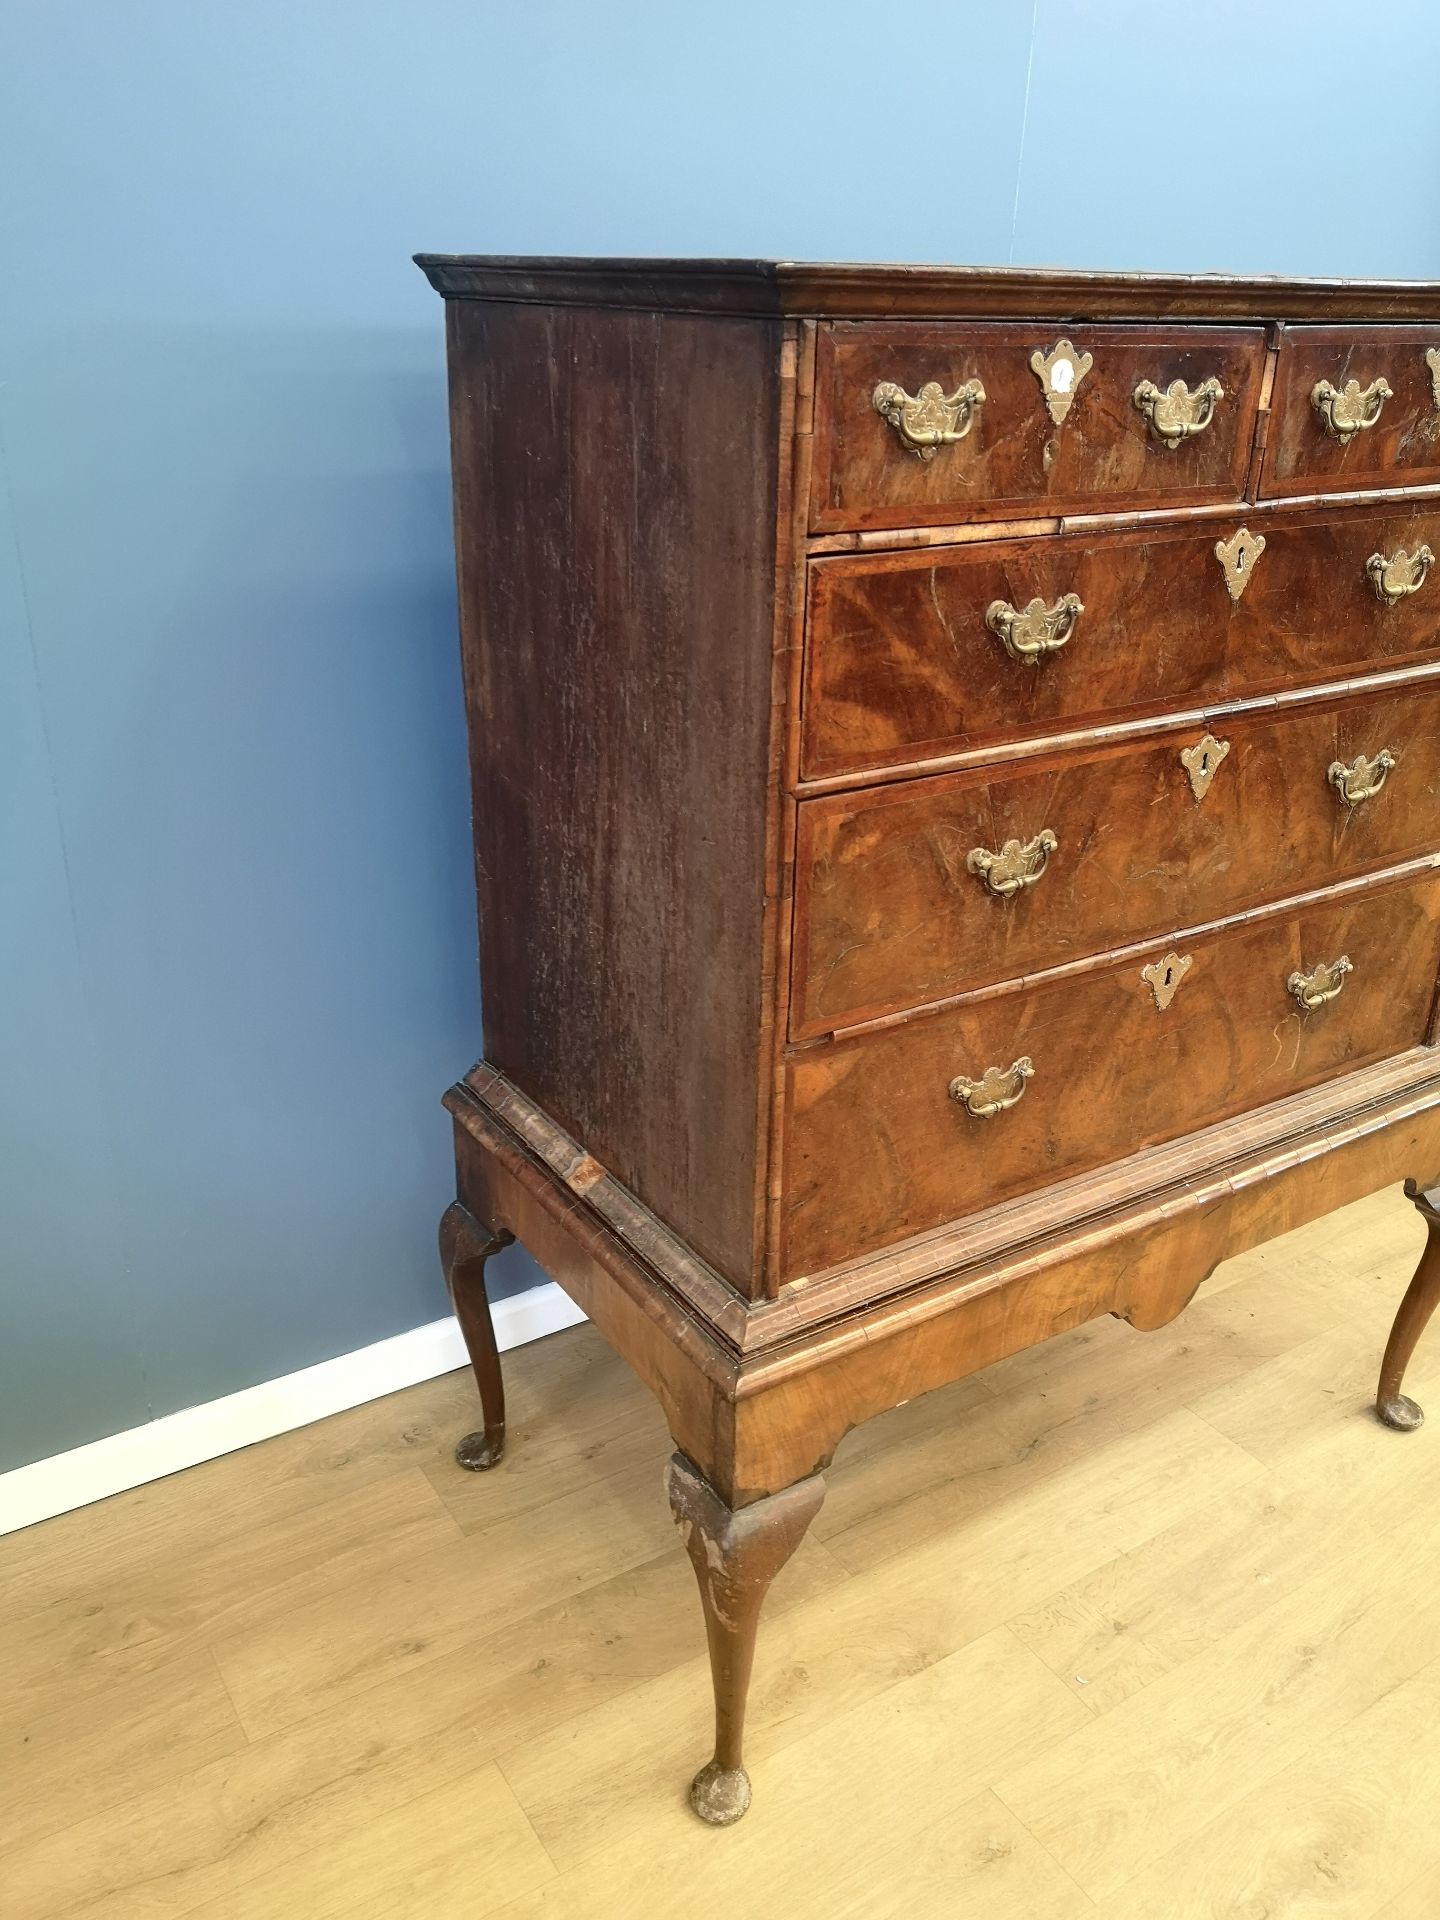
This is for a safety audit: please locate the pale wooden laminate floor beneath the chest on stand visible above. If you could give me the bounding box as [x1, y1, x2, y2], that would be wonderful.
[0, 1188, 1440, 1920]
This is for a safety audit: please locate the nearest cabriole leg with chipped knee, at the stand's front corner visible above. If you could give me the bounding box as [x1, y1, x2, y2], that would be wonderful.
[666, 1453, 826, 1826]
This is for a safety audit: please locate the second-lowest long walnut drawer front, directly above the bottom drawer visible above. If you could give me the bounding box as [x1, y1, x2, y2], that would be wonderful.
[791, 685, 1440, 1039]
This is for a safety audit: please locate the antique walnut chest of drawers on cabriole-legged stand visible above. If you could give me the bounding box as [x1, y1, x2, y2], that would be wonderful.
[408, 255, 1440, 1824]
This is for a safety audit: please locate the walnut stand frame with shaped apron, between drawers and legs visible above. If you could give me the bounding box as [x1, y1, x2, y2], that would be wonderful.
[457, 1054, 1440, 1507]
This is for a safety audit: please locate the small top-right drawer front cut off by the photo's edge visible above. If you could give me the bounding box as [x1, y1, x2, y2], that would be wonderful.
[1260, 326, 1440, 497]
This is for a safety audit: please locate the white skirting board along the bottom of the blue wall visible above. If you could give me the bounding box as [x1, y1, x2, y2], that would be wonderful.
[0, 1281, 586, 1534]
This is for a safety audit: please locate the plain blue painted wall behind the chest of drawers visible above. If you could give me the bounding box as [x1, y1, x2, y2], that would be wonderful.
[0, 0, 1440, 1467]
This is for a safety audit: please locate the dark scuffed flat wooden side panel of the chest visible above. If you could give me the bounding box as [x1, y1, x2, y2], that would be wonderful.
[449, 303, 780, 1292]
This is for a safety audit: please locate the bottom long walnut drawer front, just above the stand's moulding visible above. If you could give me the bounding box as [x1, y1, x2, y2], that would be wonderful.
[783, 877, 1440, 1279]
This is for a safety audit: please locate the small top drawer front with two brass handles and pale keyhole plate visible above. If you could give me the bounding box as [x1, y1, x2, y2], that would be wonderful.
[810, 323, 1265, 530]
